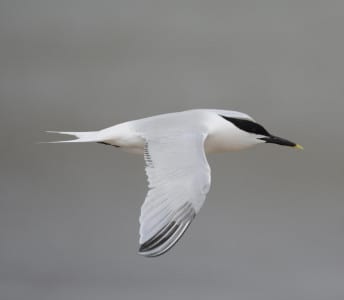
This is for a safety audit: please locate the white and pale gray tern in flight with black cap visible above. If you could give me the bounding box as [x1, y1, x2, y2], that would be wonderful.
[48, 109, 303, 257]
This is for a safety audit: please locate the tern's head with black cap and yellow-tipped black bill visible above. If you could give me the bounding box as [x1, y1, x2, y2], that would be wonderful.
[222, 114, 303, 150]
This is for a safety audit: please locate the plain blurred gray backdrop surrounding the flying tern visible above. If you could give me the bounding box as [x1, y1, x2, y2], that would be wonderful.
[0, 0, 344, 300]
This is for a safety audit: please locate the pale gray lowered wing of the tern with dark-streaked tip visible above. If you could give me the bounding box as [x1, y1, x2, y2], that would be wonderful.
[139, 134, 210, 257]
